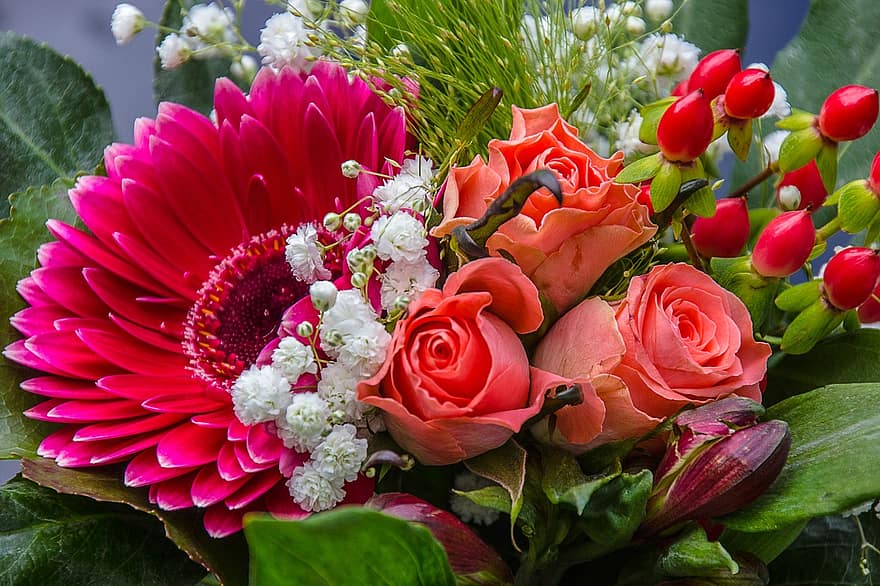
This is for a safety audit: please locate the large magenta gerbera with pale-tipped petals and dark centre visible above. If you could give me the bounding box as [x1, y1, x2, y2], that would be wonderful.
[5, 63, 407, 536]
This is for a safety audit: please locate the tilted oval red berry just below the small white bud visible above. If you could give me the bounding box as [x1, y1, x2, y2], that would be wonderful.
[752, 210, 816, 277]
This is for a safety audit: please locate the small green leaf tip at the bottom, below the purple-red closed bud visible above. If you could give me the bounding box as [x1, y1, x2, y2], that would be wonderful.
[657, 525, 739, 578]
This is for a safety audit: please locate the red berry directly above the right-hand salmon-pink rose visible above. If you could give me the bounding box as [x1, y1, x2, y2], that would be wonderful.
[691, 197, 749, 258]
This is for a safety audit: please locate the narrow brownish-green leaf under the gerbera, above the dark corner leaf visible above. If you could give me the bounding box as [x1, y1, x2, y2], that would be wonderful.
[21, 458, 247, 586]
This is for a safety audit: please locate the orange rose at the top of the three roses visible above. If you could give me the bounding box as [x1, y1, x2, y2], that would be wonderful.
[433, 104, 657, 312]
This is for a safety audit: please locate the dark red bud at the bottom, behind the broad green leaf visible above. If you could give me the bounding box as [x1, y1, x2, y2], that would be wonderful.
[366, 492, 513, 584]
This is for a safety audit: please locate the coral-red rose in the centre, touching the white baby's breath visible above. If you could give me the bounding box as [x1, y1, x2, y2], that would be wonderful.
[358, 258, 544, 465]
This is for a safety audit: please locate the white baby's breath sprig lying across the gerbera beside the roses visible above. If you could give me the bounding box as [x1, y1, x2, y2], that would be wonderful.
[231, 157, 439, 511]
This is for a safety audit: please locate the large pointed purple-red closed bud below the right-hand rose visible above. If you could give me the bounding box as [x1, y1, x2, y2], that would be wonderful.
[639, 420, 791, 535]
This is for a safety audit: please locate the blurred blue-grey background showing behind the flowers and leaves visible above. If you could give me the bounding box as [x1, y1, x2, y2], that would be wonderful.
[0, 0, 810, 483]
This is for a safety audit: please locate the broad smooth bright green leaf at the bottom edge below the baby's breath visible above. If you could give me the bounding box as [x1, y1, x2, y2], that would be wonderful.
[244, 507, 455, 586]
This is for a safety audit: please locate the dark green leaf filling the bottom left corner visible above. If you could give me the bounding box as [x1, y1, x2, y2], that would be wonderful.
[0, 478, 205, 586]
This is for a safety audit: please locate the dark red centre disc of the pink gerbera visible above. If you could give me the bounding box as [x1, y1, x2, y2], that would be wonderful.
[183, 226, 309, 390]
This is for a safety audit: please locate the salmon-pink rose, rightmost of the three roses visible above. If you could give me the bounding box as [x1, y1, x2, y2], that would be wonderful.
[532, 264, 771, 452]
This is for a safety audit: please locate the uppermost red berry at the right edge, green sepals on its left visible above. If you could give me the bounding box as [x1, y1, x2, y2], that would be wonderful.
[818, 85, 880, 142]
